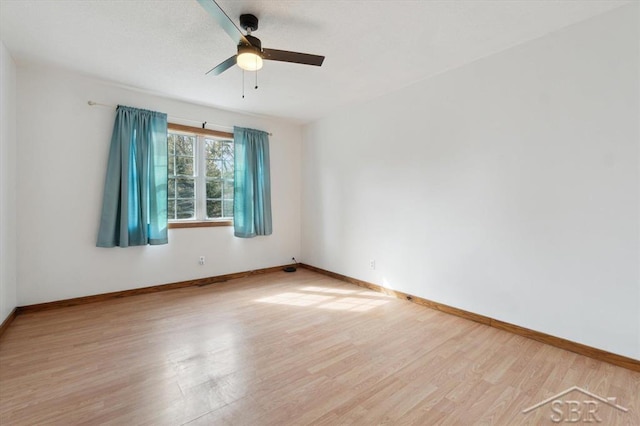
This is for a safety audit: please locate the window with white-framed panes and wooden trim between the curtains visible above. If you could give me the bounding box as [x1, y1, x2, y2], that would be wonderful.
[167, 123, 234, 228]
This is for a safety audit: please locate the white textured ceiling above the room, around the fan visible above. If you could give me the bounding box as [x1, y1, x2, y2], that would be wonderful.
[0, 0, 629, 123]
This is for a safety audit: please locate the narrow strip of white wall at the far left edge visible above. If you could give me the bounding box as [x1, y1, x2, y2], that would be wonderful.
[0, 41, 17, 323]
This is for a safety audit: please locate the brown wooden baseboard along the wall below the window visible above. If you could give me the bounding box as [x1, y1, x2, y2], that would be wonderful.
[15, 265, 293, 316]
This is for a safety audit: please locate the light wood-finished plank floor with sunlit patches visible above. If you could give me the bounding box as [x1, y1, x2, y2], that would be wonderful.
[0, 270, 640, 426]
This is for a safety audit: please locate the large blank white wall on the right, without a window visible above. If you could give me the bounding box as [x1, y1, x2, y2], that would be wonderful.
[302, 3, 640, 359]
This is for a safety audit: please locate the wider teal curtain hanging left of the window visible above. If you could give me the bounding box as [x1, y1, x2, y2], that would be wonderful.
[97, 105, 168, 247]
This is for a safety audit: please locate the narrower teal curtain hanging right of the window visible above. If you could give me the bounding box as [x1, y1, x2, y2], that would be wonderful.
[233, 127, 272, 238]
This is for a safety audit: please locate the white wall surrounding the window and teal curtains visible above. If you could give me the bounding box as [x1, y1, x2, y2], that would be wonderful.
[17, 65, 302, 306]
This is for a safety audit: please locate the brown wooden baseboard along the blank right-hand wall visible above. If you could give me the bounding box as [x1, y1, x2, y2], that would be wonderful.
[299, 263, 640, 372]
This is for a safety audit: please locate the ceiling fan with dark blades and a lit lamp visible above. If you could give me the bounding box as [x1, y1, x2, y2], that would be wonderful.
[198, 0, 324, 75]
